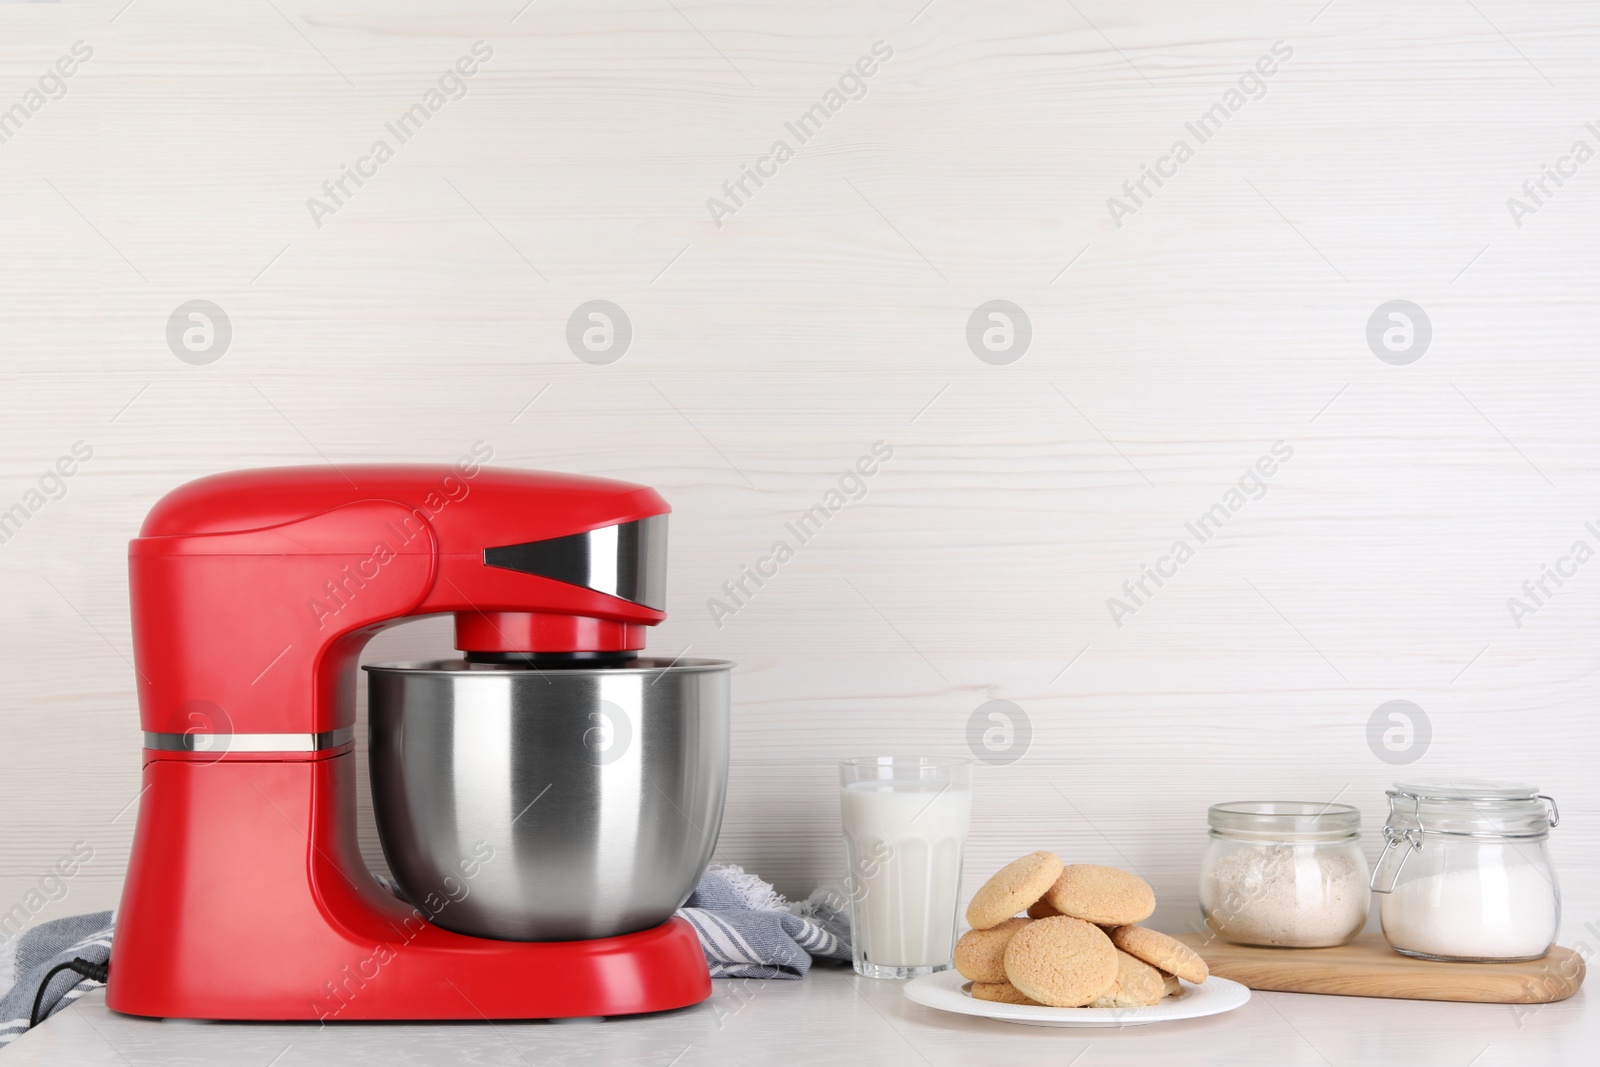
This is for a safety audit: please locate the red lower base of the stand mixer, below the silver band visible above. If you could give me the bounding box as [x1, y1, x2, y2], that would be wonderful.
[106, 749, 710, 1022]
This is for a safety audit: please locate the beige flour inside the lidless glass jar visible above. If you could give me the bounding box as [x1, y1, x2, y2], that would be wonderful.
[1200, 845, 1371, 949]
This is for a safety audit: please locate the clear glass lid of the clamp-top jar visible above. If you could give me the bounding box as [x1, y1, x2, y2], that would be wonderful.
[1384, 777, 1560, 838]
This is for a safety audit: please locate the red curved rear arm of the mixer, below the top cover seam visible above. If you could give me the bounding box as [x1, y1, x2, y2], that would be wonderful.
[128, 501, 438, 734]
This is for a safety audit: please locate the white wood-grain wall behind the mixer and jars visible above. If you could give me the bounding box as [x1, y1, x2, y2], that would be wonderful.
[0, 0, 1600, 936]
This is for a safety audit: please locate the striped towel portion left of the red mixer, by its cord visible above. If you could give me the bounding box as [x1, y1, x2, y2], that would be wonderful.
[0, 912, 112, 1048]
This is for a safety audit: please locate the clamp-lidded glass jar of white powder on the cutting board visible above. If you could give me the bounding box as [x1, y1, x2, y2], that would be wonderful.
[1373, 779, 1562, 963]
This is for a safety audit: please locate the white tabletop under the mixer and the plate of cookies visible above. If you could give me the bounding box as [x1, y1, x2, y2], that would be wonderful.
[5, 966, 1600, 1067]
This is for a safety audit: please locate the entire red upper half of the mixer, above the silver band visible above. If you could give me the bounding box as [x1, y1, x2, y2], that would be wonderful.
[130, 459, 670, 734]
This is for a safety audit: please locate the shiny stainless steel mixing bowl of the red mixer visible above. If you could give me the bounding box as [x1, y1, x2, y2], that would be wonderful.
[366, 659, 733, 941]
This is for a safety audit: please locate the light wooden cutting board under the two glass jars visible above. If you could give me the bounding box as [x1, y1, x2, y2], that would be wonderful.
[1179, 933, 1584, 1005]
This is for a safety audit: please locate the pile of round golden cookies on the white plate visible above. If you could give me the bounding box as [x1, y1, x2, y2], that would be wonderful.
[955, 853, 1208, 1008]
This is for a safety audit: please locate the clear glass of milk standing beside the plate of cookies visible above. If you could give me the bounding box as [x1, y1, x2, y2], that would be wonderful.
[838, 755, 973, 977]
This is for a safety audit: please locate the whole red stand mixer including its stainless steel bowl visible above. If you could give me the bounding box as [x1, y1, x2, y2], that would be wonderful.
[107, 459, 731, 1021]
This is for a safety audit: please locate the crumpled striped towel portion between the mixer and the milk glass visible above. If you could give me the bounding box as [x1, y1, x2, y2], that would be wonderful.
[678, 865, 850, 979]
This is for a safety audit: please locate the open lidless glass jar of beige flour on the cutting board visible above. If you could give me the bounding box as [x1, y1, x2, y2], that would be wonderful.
[1200, 800, 1371, 949]
